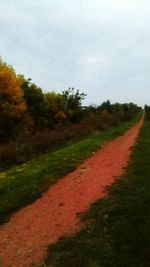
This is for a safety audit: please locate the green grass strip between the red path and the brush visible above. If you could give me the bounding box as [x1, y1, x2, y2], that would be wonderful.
[0, 115, 141, 224]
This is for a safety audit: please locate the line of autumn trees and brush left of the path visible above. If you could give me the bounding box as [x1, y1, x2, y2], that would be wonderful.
[0, 60, 139, 169]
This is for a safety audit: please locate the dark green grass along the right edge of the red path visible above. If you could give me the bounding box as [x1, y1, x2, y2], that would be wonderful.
[45, 121, 150, 267]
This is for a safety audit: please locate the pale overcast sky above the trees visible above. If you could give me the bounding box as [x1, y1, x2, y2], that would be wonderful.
[0, 0, 150, 105]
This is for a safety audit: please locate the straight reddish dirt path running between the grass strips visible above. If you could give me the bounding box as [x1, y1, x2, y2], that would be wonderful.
[0, 120, 142, 267]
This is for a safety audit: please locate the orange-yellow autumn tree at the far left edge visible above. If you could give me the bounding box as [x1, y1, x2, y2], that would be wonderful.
[0, 59, 26, 141]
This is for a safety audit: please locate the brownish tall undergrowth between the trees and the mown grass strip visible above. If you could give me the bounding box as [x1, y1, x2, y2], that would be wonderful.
[0, 112, 140, 171]
